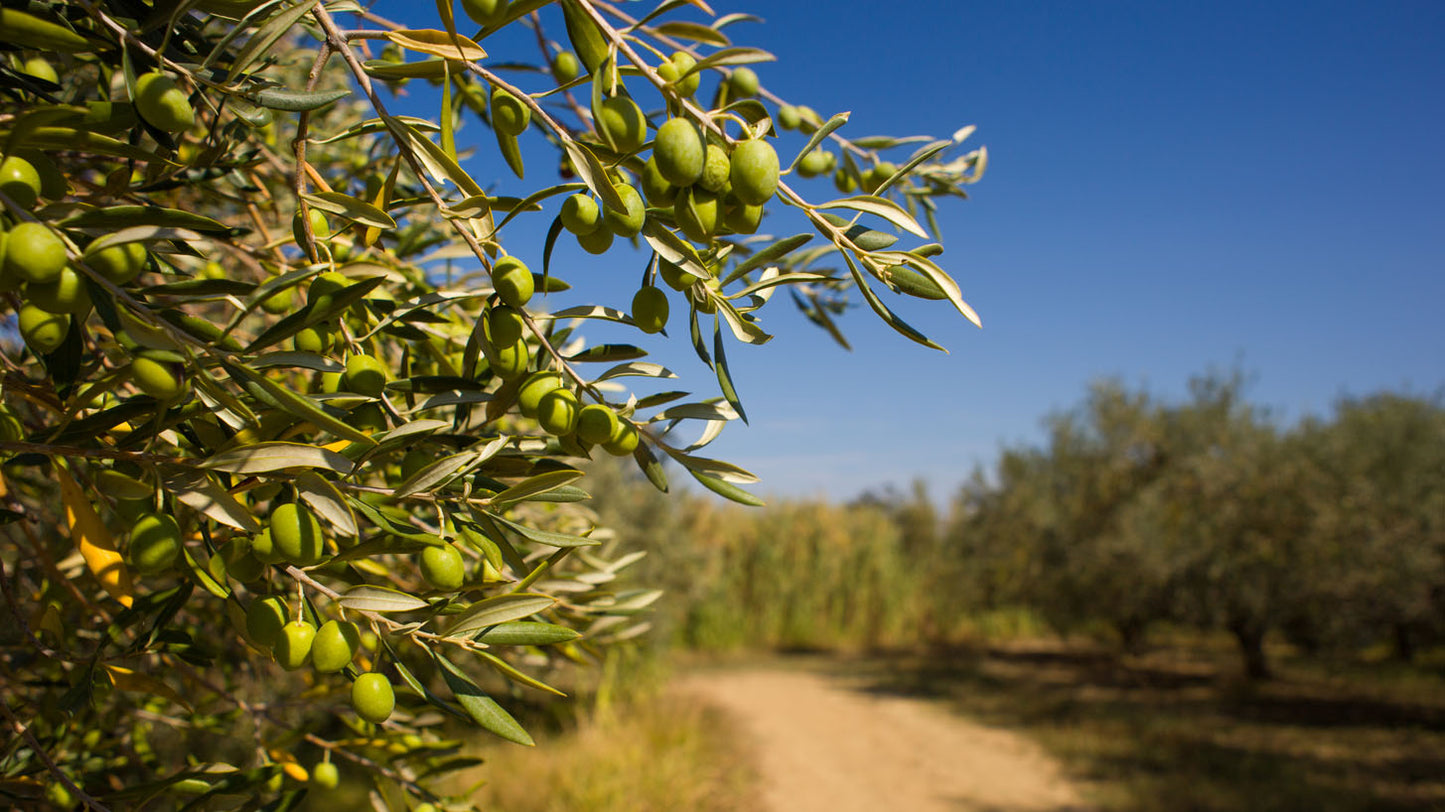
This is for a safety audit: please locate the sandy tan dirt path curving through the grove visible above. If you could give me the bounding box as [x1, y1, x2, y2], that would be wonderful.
[681, 669, 1085, 812]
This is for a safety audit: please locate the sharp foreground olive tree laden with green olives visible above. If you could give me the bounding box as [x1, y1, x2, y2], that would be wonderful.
[0, 0, 985, 809]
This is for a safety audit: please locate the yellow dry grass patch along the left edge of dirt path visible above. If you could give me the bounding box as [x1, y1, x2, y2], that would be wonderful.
[457, 691, 757, 812]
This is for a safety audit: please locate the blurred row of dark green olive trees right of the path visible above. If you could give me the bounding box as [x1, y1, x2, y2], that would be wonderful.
[944, 373, 1445, 678]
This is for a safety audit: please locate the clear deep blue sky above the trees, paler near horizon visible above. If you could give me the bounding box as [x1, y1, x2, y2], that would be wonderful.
[379, 0, 1445, 500]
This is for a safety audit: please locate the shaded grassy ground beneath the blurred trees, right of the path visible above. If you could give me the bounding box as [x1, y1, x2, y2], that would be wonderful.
[820, 643, 1445, 812]
